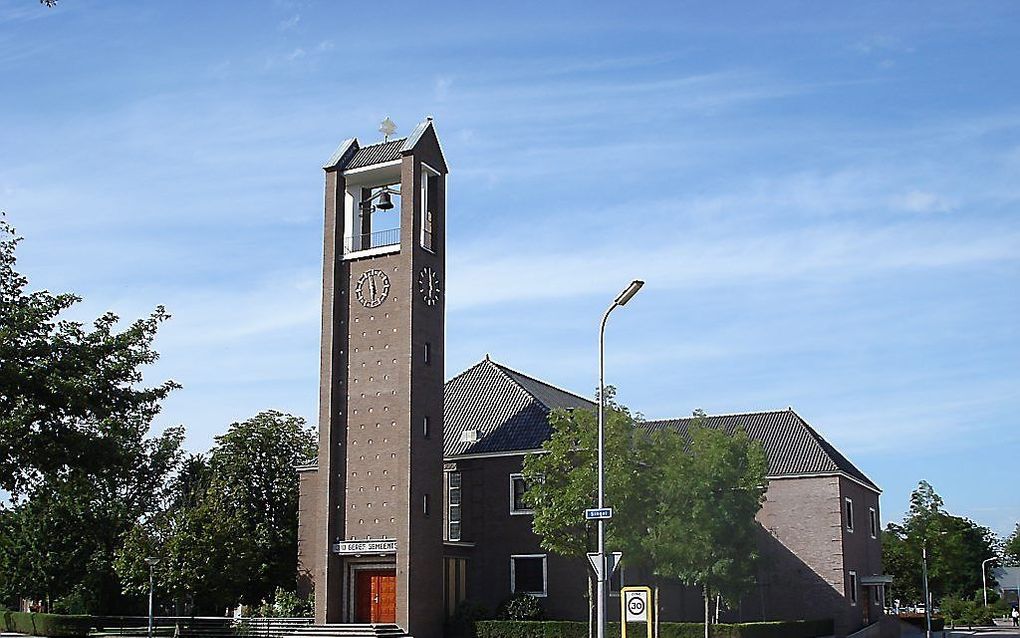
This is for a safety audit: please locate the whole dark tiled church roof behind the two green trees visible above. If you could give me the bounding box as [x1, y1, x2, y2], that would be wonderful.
[444, 356, 879, 490]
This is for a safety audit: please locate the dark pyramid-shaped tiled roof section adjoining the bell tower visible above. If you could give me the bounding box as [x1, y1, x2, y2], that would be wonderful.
[443, 356, 595, 456]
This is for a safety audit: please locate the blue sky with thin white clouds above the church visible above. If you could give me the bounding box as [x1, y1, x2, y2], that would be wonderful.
[0, 0, 1020, 532]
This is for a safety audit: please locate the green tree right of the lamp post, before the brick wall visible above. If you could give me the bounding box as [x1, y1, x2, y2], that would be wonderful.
[645, 413, 766, 637]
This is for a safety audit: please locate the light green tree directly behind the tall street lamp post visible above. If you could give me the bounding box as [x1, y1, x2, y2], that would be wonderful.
[523, 394, 658, 628]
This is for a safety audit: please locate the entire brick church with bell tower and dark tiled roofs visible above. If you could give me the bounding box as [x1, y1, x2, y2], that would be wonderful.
[298, 118, 887, 638]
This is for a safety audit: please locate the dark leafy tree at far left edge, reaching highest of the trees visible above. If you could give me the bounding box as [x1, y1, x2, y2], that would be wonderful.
[0, 217, 180, 499]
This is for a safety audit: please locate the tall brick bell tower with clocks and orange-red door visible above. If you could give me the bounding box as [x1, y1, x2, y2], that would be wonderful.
[298, 117, 447, 638]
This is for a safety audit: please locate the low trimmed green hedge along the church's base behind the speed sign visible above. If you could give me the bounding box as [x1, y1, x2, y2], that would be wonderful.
[474, 620, 833, 638]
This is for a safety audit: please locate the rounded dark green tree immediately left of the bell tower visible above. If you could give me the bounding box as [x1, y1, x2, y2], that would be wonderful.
[116, 410, 315, 612]
